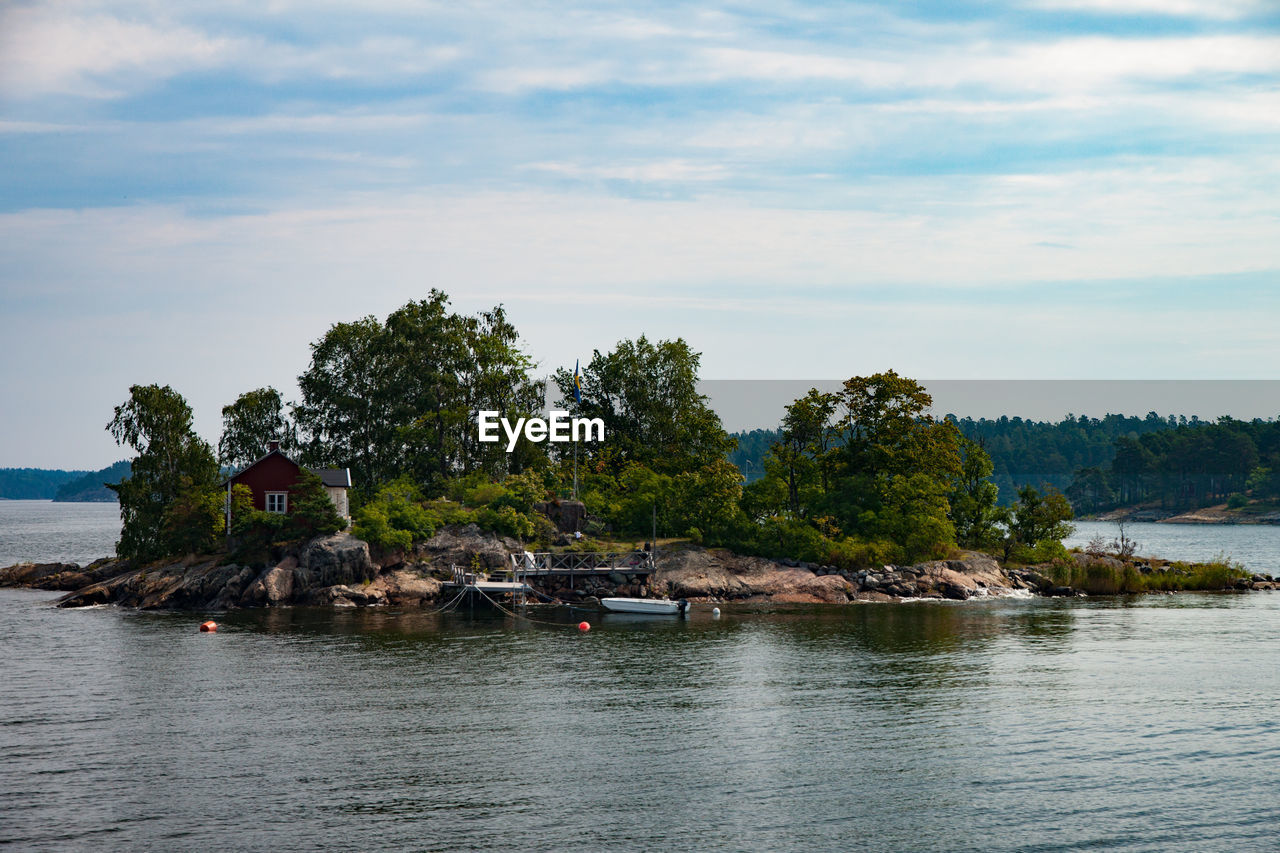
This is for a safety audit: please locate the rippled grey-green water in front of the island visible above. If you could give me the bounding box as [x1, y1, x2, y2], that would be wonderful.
[0, 590, 1280, 850]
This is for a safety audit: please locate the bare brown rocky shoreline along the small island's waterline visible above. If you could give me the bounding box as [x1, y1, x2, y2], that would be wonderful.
[0, 525, 1280, 611]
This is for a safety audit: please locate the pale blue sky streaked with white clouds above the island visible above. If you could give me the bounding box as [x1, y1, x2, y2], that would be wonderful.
[0, 0, 1280, 469]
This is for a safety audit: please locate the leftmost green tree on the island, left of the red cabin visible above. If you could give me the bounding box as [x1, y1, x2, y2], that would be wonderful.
[106, 386, 218, 562]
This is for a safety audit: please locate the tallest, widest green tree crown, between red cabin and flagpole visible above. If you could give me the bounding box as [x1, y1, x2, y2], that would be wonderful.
[294, 289, 543, 494]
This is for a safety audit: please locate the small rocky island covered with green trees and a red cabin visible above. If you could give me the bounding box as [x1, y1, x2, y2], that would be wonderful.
[0, 291, 1274, 610]
